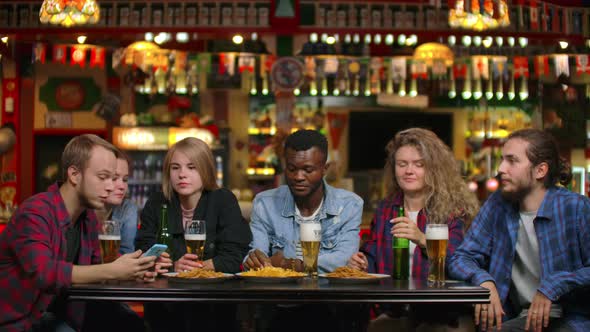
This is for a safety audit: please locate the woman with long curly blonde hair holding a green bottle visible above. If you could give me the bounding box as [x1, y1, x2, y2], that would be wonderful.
[348, 128, 479, 332]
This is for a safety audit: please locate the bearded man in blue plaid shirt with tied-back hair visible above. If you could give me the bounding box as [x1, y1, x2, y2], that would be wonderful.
[449, 129, 590, 331]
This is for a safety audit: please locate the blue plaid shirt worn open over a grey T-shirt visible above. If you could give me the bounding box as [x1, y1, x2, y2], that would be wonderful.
[449, 188, 590, 331]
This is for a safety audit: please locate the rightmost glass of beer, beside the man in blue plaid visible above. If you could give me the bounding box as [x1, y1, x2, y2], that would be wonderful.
[426, 224, 449, 286]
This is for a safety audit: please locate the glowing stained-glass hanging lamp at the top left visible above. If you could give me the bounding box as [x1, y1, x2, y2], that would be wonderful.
[39, 0, 100, 27]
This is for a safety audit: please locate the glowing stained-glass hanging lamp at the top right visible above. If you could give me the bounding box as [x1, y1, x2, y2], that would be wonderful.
[449, 0, 510, 31]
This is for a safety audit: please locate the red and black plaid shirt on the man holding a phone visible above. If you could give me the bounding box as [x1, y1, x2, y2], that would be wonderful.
[0, 184, 100, 331]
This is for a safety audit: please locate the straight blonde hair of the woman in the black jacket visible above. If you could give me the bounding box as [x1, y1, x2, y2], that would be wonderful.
[162, 137, 219, 200]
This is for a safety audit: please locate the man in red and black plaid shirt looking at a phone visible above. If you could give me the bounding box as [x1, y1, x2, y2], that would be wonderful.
[0, 135, 155, 331]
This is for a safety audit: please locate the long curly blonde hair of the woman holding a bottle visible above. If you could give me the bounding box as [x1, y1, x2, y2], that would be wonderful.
[384, 128, 479, 228]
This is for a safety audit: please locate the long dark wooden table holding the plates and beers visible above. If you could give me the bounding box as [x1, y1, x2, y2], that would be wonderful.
[67, 278, 490, 304]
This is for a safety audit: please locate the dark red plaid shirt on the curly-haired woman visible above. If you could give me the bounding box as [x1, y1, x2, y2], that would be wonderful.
[361, 193, 464, 280]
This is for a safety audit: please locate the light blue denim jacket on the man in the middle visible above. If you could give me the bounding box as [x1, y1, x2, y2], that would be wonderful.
[244, 183, 363, 273]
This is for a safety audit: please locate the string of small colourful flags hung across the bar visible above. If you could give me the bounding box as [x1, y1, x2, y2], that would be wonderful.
[33, 43, 590, 96]
